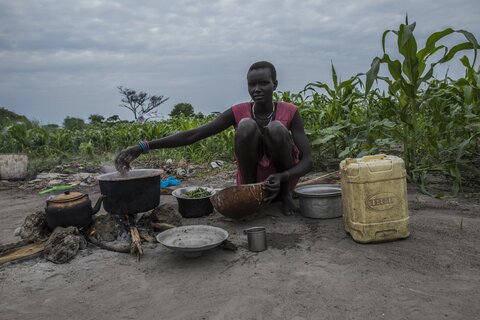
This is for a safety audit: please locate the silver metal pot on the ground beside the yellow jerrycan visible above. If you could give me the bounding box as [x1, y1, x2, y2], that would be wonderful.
[294, 184, 343, 219]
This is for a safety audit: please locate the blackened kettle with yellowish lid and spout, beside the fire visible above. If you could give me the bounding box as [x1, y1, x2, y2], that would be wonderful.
[45, 191, 103, 230]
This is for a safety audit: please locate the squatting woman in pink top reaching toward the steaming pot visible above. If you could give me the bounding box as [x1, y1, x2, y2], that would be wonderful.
[115, 61, 313, 215]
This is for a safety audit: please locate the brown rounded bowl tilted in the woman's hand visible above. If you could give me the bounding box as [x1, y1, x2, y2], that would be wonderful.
[210, 182, 267, 219]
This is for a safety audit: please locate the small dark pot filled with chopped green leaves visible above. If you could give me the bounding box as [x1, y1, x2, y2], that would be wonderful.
[172, 186, 215, 218]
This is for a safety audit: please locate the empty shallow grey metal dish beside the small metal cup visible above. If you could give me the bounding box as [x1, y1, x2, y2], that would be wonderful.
[157, 225, 228, 258]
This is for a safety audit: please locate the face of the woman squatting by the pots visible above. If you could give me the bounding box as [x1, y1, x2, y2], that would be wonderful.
[247, 68, 278, 104]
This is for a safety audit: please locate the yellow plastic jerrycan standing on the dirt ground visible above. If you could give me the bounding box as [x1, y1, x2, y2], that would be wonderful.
[340, 154, 410, 243]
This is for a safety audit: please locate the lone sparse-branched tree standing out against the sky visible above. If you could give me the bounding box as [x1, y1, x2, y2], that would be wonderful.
[117, 86, 170, 120]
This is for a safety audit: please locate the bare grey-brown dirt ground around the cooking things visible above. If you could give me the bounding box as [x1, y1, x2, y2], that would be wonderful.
[0, 170, 480, 320]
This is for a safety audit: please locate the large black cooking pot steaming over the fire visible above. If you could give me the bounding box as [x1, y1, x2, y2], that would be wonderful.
[97, 169, 162, 216]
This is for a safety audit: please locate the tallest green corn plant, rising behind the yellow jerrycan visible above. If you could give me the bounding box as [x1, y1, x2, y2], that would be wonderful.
[365, 17, 478, 190]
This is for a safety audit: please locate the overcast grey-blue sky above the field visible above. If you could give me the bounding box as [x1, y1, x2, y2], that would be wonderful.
[0, 0, 480, 124]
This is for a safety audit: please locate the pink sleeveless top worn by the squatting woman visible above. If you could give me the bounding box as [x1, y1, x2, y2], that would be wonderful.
[232, 102, 300, 188]
